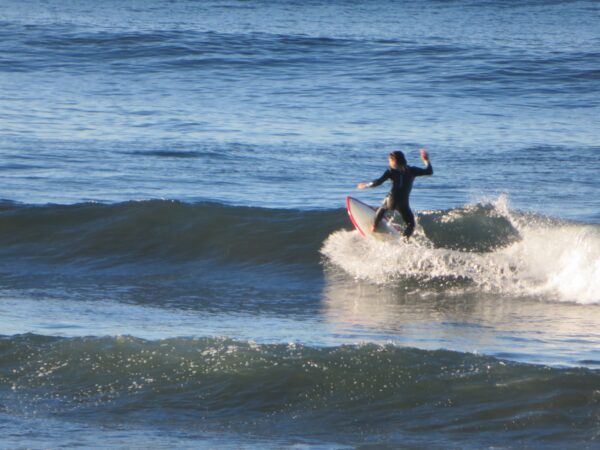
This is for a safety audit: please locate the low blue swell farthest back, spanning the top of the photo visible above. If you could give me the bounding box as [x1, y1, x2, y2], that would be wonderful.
[0, 24, 599, 107]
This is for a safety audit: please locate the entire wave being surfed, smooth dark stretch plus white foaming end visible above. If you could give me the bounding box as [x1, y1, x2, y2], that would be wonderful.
[0, 199, 600, 303]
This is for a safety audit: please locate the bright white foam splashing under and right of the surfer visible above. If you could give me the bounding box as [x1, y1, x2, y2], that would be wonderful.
[322, 197, 600, 304]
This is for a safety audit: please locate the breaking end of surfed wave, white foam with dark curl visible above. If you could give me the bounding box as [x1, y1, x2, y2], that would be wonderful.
[322, 198, 600, 303]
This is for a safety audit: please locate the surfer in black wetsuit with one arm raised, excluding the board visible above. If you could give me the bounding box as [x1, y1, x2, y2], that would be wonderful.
[356, 148, 433, 239]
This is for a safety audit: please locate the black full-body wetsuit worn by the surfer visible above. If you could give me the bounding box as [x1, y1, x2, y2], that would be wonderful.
[369, 162, 433, 237]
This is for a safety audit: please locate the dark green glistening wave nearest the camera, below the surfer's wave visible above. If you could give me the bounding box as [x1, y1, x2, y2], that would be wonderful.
[0, 335, 600, 445]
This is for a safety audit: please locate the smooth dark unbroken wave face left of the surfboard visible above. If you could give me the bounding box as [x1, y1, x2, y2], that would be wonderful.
[0, 200, 345, 265]
